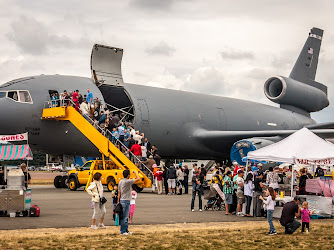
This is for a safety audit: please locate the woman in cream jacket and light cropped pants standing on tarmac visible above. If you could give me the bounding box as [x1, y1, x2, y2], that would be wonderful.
[86, 172, 107, 229]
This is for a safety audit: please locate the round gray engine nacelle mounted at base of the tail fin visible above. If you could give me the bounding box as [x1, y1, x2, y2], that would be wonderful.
[264, 76, 329, 112]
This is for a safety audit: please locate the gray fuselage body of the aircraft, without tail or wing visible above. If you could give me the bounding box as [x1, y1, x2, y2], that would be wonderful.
[0, 75, 315, 159]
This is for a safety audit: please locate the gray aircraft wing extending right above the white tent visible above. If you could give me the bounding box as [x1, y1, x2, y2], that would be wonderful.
[196, 129, 334, 141]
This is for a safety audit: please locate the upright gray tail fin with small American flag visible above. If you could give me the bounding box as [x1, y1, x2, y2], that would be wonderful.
[289, 28, 324, 82]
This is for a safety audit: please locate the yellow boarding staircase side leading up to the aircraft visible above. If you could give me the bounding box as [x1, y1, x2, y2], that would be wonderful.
[42, 106, 152, 187]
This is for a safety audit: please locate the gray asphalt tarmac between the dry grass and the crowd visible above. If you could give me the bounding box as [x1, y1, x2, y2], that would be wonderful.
[0, 185, 265, 230]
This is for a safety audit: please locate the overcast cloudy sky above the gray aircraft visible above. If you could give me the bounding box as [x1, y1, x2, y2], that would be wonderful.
[0, 0, 334, 122]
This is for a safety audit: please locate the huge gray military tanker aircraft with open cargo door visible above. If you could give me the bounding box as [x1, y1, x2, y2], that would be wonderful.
[0, 28, 334, 160]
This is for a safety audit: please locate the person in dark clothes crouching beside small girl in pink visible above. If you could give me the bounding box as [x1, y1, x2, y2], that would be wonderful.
[280, 196, 301, 234]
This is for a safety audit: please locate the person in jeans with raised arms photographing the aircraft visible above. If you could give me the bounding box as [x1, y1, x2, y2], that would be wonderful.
[118, 169, 140, 235]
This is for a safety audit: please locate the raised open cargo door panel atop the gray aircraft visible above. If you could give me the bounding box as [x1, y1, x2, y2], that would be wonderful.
[90, 44, 124, 87]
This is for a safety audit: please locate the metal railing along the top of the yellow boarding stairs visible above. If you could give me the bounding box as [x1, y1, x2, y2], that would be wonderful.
[44, 99, 153, 174]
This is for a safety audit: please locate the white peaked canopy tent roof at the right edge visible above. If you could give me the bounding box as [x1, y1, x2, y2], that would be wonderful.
[247, 128, 334, 165]
